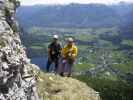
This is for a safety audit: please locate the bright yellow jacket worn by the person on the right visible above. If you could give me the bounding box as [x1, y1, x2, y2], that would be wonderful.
[61, 44, 78, 58]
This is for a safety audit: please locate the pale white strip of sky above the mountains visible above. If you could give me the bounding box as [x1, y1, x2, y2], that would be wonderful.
[20, 0, 133, 5]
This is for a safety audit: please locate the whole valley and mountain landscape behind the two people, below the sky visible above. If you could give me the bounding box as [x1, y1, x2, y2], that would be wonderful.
[17, 4, 133, 100]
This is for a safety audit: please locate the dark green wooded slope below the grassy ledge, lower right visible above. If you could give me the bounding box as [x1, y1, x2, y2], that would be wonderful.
[76, 76, 133, 100]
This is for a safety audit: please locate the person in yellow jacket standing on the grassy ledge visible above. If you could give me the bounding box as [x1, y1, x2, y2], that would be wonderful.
[60, 38, 78, 77]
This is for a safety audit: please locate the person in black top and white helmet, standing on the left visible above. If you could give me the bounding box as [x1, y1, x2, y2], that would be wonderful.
[46, 35, 61, 72]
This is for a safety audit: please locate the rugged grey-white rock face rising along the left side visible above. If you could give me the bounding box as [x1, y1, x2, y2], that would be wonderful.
[0, 0, 39, 100]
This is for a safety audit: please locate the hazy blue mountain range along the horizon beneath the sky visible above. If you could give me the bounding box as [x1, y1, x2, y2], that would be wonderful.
[17, 4, 133, 27]
